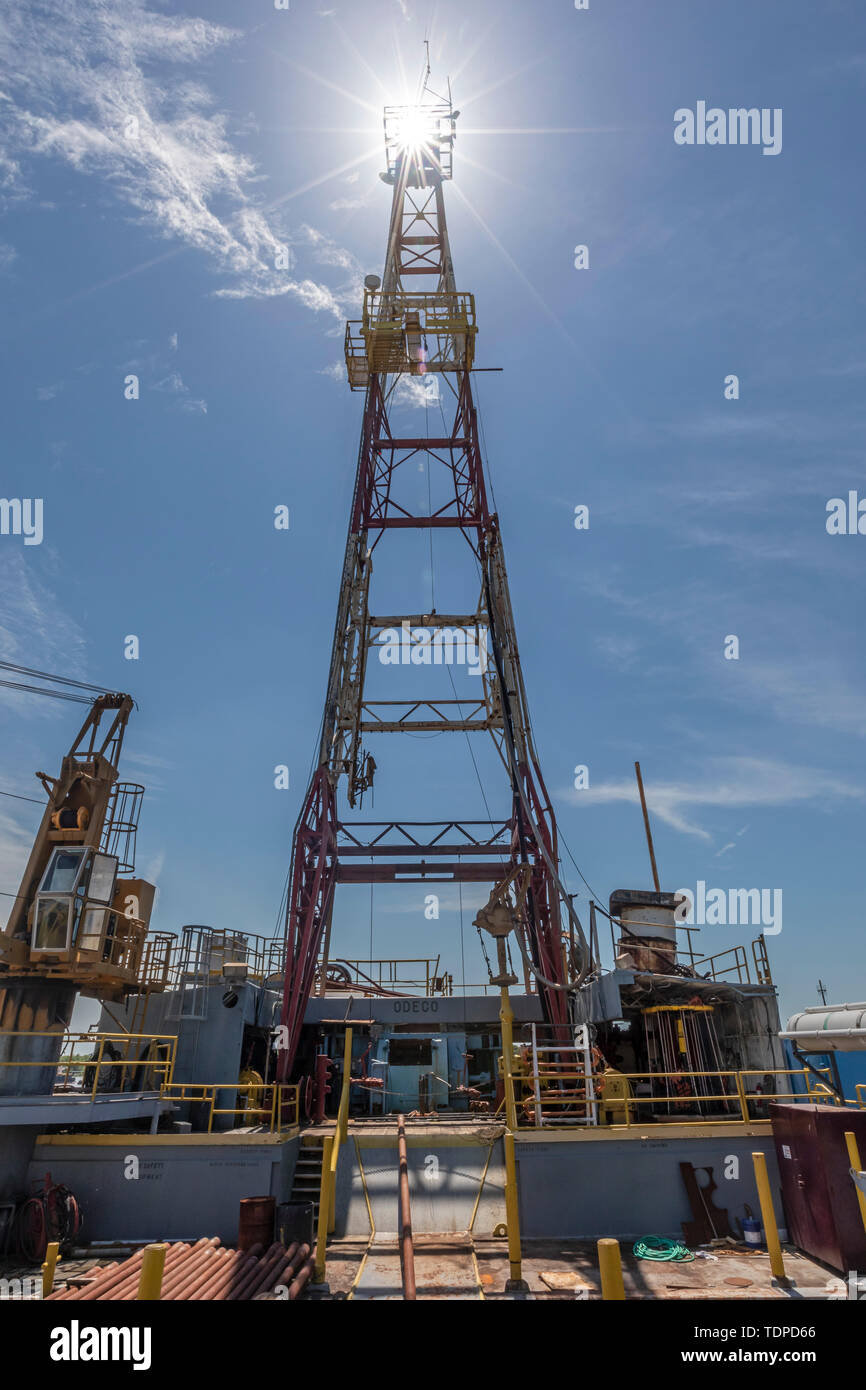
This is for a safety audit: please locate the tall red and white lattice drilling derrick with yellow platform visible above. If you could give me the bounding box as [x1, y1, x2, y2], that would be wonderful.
[281, 92, 587, 1076]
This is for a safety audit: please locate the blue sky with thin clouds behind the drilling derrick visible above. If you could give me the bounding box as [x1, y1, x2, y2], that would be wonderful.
[0, 0, 866, 1011]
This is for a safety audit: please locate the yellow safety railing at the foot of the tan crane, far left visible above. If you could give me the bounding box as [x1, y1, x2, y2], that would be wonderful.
[0, 1029, 178, 1098]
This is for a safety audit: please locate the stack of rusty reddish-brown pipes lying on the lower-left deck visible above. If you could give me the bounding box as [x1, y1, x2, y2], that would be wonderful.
[49, 1236, 316, 1302]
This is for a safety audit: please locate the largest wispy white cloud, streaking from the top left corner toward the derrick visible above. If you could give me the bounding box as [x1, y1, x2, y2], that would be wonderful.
[0, 0, 346, 313]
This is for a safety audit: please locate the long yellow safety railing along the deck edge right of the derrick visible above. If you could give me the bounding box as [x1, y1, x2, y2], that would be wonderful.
[513, 1049, 839, 1129]
